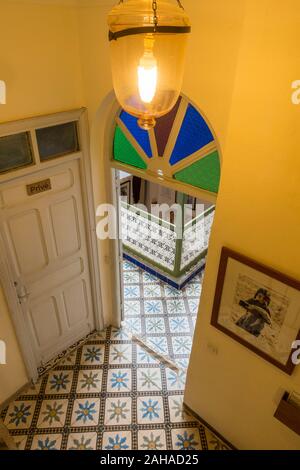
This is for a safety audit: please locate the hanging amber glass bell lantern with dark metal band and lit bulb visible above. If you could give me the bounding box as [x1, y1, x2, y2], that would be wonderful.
[108, 0, 190, 129]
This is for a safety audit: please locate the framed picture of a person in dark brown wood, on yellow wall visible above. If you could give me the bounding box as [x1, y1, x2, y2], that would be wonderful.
[211, 248, 300, 374]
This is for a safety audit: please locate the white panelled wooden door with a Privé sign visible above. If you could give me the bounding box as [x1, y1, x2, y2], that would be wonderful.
[0, 160, 94, 366]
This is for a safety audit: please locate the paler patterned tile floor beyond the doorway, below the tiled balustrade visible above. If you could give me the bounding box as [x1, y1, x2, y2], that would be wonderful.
[123, 261, 203, 369]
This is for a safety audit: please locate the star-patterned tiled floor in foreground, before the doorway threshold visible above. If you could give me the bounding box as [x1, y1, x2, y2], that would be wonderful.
[0, 326, 226, 450]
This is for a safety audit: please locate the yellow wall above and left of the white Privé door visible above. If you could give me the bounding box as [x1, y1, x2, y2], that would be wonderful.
[0, 1, 84, 404]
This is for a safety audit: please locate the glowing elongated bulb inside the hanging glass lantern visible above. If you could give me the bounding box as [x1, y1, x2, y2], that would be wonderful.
[138, 50, 158, 103]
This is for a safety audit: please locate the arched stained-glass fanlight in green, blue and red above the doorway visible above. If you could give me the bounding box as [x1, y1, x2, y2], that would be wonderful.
[113, 96, 221, 194]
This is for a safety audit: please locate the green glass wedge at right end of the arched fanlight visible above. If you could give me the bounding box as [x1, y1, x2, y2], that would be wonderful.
[174, 151, 221, 193]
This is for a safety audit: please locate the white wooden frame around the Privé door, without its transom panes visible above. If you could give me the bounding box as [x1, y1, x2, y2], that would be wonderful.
[0, 108, 104, 381]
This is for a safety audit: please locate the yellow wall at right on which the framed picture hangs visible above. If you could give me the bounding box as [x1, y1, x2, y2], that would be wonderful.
[185, 0, 300, 449]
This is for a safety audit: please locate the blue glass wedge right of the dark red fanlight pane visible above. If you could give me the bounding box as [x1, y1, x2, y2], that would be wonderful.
[170, 104, 214, 165]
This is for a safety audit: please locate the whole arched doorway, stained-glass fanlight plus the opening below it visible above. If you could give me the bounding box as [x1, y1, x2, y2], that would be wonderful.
[107, 95, 221, 369]
